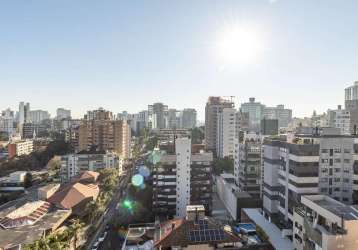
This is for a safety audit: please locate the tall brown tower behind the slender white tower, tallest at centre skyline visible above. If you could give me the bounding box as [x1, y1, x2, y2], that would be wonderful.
[205, 96, 234, 154]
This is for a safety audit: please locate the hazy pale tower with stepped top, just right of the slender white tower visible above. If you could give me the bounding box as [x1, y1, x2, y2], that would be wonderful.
[241, 97, 265, 132]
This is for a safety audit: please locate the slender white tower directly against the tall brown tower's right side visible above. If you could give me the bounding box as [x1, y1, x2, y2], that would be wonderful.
[216, 108, 236, 158]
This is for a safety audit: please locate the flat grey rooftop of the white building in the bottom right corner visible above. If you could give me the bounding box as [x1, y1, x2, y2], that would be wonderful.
[301, 195, 358, 220]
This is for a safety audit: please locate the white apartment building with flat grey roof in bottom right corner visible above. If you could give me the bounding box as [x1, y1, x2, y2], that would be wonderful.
[293, 195, 358, 250]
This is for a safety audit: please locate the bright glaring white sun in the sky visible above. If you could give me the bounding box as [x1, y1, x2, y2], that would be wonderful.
[217, 25, 263, 67]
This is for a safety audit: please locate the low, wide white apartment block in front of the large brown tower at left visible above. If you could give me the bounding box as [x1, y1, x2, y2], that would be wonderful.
[61, 153, 123, 182]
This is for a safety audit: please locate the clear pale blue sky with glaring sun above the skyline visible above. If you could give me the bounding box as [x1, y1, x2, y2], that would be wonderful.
[0, 0, 358, 120]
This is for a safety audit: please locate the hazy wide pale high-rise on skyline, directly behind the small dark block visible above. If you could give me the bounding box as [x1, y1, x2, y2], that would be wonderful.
[263, 105, 292, 128]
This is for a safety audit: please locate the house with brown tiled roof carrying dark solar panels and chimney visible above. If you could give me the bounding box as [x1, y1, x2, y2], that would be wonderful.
[154, 205, 242, 249]
